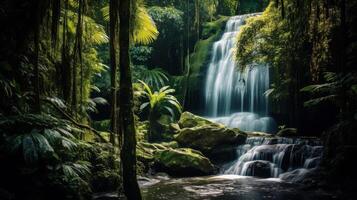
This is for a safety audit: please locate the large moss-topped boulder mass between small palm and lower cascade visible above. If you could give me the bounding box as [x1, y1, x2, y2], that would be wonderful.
[175, 112, 247, 162]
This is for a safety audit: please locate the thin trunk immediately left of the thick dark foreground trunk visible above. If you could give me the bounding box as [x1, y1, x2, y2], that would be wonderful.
[109, 0, 119, 145]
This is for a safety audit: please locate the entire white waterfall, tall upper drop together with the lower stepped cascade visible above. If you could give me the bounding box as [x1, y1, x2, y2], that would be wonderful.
[205, 14, 322, 183]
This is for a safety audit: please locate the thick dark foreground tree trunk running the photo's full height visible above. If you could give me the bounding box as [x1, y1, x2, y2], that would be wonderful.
[119, 0, 141, 200]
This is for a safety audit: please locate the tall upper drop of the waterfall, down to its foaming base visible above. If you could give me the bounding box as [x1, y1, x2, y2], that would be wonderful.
[205, 14, 276, 133]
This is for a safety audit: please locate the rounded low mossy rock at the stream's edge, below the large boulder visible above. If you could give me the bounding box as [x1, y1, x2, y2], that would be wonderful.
[154, 148, 215, 177]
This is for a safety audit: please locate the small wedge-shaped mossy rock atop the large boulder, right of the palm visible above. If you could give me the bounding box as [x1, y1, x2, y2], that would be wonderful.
[178, 112, 224, 131]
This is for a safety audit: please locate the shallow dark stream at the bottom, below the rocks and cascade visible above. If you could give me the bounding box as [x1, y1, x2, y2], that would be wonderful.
[141, 175, 337, 200]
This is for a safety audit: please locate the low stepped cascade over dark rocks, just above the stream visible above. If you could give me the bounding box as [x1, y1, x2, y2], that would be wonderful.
[222, 137, 323, 178]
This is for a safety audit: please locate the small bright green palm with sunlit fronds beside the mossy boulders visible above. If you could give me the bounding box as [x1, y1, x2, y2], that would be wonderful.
[140, 81, 182, 141]
